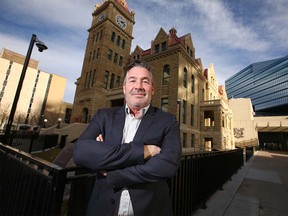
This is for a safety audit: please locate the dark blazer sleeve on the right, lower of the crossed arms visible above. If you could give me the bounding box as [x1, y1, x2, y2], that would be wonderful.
[107, 115, 182, 187]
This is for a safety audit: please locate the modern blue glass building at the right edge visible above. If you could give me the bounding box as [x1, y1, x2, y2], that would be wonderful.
[225, 56, 288, 115]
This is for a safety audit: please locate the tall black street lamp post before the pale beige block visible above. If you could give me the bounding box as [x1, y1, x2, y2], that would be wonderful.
[2, 34, 48, 144]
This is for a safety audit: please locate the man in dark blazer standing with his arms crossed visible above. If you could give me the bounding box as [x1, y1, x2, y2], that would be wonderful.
[74, 60, 181, 216]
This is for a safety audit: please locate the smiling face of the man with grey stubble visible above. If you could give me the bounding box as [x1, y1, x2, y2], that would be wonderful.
[123, 66, 155, 109]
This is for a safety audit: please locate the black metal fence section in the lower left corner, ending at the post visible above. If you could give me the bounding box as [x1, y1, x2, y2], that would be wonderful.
[0, 144, 67, 215]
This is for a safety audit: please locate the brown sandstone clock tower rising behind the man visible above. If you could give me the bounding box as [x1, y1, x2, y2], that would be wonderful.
[71, 0, 135, 123]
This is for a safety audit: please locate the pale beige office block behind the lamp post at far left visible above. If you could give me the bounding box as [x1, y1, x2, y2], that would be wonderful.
[0, 48, 71, 129]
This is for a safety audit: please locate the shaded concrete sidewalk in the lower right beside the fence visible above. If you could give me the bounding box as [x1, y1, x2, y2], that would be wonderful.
[193, 151, 288, 216]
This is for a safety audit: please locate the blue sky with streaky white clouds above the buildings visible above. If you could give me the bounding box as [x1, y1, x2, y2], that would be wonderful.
[0, 0, 288, 103]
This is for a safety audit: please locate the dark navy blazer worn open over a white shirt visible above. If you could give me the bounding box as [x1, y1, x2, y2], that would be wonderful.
[74, 106, 181, 216]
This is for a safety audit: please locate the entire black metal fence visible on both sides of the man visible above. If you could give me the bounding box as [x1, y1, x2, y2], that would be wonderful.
[0, 144, 243, 215]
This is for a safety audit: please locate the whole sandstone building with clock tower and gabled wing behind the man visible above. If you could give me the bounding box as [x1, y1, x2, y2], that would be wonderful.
[71, 0, 235, 150]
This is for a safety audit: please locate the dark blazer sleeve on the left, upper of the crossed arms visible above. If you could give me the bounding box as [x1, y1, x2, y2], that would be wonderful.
[73, 110, 144, 171]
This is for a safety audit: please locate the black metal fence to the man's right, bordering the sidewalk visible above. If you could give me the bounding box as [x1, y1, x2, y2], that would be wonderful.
[170, 149, 243, 215]
